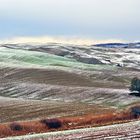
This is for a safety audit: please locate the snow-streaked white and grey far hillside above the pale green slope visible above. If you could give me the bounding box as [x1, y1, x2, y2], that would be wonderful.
[1, 43, 140, 69]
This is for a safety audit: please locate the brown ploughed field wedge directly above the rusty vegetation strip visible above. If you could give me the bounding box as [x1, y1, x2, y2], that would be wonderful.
[0, 97, 113, 123]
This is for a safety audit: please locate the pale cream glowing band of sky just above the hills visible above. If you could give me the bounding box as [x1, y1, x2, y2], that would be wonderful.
[0, 36, 139, 45]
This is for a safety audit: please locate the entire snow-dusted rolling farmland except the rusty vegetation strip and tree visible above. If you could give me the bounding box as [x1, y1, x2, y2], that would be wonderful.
[0, 43, 140, 140]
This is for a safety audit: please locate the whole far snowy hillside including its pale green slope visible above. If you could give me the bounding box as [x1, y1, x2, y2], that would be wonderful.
[0, 43, 140, 69]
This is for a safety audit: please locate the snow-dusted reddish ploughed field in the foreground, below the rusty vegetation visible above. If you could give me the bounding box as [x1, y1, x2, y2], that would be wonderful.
[2, 121, 140, 140]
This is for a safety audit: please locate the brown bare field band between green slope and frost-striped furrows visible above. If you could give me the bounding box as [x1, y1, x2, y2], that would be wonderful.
[0, 68, 140, 89]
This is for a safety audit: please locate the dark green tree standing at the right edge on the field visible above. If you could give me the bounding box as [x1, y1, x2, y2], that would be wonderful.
[130, 77, 140, 93]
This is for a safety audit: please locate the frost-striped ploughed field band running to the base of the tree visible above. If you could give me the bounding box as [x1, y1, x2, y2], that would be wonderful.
[0, 82, 140, 106]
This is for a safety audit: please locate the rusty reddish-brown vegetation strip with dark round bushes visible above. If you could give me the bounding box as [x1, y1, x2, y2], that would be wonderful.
[0, 112, 138, 137]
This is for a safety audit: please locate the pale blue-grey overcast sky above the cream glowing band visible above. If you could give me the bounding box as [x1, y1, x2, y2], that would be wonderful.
[0, 0, 140, 41]
